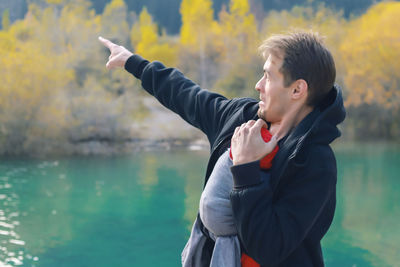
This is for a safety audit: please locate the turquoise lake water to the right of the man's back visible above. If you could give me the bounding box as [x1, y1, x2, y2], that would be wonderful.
[323, 144, 400, 267]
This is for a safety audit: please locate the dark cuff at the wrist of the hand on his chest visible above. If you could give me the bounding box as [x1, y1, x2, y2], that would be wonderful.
[231, 160, 261, 188]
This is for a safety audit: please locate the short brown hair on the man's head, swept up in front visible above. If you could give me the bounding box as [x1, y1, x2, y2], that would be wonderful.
[259, 31, 336, 106]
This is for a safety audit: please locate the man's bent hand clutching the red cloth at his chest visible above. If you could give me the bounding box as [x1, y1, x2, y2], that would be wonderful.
[231, 119, 278, 165]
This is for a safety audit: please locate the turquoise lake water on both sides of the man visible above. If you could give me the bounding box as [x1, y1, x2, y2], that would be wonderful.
[0, 144, 400, 267]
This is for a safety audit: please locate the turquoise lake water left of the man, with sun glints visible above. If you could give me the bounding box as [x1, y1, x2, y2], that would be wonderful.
[0, 155, 205, 267]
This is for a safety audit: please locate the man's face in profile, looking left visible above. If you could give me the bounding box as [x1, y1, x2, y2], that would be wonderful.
[256, 54, 290, 123]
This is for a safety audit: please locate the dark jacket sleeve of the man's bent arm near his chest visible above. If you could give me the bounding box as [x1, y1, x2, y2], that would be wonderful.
[230, 146, 336, 266]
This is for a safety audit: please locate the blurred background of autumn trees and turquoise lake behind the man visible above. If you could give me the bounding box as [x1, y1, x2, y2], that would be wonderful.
[0, 0, 400, 267]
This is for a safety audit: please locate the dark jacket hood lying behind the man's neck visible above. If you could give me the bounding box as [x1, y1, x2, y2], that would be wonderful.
[284, 85, 346, 158]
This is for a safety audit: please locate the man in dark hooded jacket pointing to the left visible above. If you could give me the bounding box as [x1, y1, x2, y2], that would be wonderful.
[100, 32, 345, 266]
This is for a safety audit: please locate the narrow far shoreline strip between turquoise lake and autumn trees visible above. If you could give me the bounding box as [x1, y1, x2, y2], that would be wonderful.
[0, 137, 400, 159]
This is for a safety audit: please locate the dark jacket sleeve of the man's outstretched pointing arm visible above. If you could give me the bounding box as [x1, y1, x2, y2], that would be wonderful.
[125, 55, 244, 142]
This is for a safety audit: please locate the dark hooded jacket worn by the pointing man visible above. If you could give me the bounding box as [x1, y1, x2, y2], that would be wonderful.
[125, 55, 345, 267]
